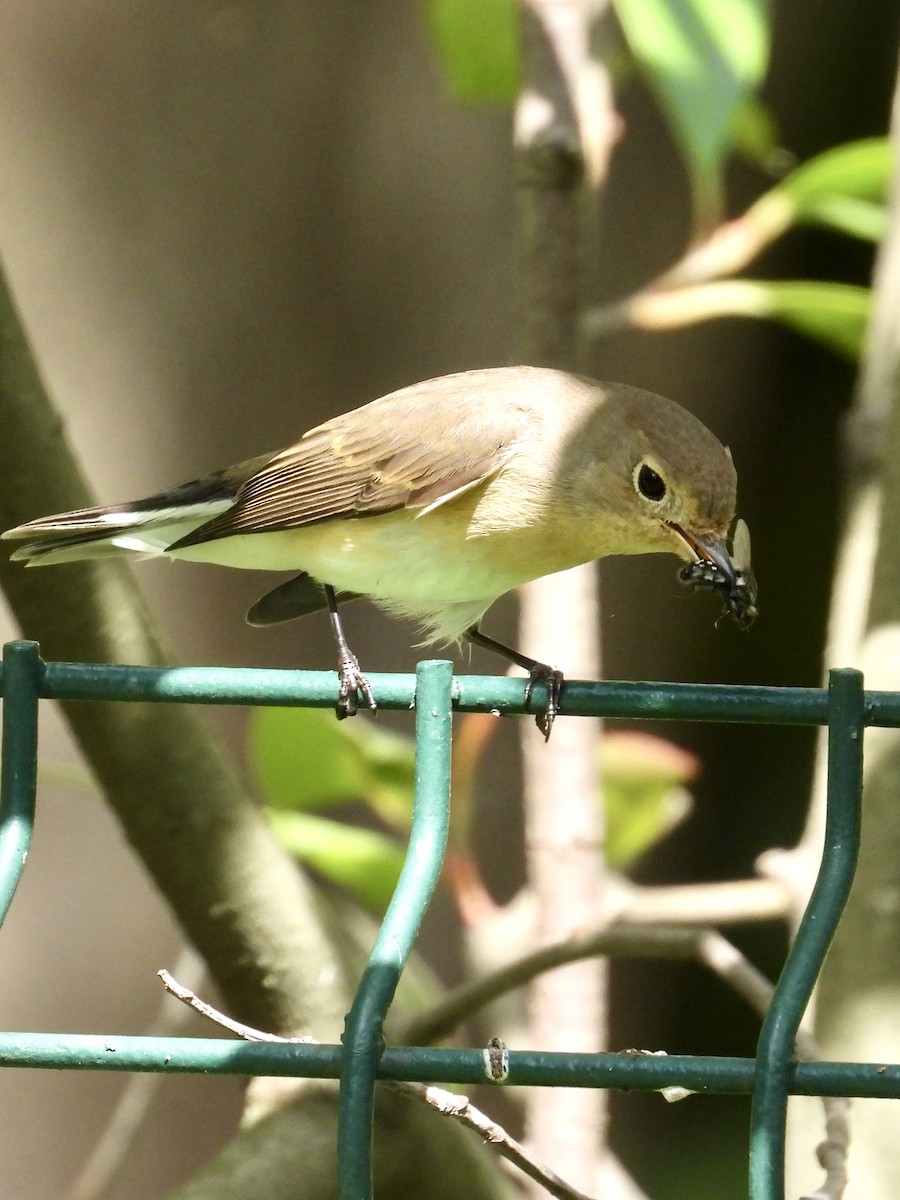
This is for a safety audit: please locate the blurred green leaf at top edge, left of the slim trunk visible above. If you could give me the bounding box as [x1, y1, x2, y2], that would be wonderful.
[426, 0, 522, 104]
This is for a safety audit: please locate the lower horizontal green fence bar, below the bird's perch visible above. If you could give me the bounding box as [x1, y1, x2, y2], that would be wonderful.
[0, 1033, 900, 1099]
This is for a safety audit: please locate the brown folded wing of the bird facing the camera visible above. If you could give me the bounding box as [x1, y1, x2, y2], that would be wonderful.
[170, 389, 529, 550]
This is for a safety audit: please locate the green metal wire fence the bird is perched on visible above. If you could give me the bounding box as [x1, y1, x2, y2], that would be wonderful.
[0, 642, 900, 1200]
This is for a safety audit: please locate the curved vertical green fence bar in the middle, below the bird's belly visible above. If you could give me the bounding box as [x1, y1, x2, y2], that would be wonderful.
[337, 661, 452, 1200]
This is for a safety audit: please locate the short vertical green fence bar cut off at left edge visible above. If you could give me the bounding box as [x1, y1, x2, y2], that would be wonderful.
[0, 642, 43, 924]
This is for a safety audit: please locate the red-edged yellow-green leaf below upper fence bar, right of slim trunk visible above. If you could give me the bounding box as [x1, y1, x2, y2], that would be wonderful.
[600, 733, 700, 868]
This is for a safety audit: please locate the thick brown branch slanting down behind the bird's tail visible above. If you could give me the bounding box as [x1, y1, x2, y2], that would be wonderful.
[0, 262, 346, 1030]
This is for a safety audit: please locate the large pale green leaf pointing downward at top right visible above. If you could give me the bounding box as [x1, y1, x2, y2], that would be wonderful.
[616, 0, 769, 220]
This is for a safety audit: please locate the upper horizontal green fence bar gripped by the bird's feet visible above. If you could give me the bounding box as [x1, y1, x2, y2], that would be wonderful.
[0, 662, 900, 727]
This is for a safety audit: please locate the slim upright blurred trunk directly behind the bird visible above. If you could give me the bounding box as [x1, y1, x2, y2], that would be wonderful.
[515, 0, 613, 1193]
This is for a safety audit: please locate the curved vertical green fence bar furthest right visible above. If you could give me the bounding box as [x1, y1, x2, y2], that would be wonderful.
[750, 670, 865, 1200]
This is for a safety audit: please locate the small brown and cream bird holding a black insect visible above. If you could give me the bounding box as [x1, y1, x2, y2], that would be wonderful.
[2, 366, 757, 738]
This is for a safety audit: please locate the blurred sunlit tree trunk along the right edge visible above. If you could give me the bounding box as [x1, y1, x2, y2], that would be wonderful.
[788, 44, 900, 1200]
